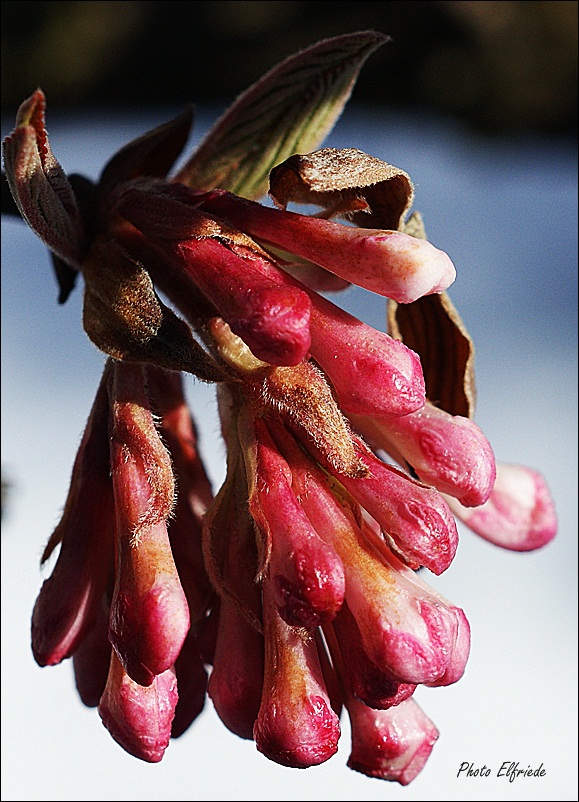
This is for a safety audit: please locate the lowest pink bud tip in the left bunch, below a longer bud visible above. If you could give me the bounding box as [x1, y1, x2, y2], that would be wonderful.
[98, 652, 178, 763]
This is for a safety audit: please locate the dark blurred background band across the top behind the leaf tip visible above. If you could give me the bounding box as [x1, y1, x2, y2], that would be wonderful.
[1, 0, 577, 134]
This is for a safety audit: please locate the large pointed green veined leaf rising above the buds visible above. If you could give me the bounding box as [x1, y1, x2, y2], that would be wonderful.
[175, 31, 389, 199]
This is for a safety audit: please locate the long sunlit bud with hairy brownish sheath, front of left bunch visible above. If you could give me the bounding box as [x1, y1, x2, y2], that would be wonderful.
[109, 362, 189, 685]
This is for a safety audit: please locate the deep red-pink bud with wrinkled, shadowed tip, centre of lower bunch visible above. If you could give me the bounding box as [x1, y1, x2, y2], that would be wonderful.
[242, 420, 344, 627]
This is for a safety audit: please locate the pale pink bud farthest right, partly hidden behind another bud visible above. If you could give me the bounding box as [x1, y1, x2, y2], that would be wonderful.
[448, 462, 557, 551]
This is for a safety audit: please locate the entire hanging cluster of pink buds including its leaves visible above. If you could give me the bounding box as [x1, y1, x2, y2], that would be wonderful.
[4, 32, 556, 785]
